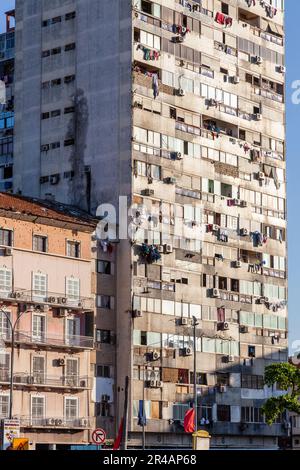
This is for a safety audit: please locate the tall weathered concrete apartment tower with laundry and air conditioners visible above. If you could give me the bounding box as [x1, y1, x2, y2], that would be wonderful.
[14, 0, 287, 448]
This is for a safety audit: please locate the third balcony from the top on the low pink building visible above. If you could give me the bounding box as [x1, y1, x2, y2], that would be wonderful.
[0, 370, 92, 390]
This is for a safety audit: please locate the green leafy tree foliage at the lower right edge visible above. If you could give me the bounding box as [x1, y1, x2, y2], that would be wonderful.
[262, 363, 300, 425]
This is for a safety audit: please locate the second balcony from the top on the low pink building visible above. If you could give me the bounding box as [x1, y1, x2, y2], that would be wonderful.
[0, 328, 94, 349]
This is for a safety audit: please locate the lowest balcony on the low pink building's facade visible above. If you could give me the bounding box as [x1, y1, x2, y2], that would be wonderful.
[20, 416, 92, 430]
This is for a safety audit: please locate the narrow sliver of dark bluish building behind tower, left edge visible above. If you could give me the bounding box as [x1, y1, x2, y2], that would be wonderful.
[0, 11, 15, 191]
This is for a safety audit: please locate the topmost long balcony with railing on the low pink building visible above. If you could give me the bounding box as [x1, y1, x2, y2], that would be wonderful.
[0, 287, 95, 311]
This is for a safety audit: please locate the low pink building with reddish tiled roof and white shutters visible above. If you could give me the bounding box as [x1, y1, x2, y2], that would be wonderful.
[0, 194, 95, 449]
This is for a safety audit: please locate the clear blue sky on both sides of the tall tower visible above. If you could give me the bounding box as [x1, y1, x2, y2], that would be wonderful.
[0, 0, 300, 352]
